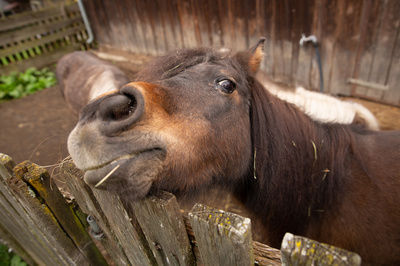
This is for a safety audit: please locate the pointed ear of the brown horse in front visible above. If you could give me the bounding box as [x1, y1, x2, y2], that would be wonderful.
[235, 37, 265, 74]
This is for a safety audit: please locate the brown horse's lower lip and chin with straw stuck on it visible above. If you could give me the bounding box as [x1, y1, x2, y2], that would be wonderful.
[84, 149, 165, 200]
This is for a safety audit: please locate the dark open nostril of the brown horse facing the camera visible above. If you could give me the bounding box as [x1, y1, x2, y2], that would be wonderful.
[99, 94, 137, 121]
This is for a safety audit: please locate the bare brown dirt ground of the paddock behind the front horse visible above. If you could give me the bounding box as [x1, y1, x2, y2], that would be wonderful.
[0, 50, 400, 197]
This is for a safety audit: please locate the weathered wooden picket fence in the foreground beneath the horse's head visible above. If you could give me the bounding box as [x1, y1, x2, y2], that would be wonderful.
[0, 153, 361, 265]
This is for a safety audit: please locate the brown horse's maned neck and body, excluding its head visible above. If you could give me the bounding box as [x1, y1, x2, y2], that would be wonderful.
[245, 78, 400, 264]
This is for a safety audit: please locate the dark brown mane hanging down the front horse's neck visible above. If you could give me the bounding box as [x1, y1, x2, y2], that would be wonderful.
[248, 81, 351, 237]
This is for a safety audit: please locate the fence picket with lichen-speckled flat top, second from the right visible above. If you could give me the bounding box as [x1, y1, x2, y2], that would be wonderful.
[189, 204, 254, 265]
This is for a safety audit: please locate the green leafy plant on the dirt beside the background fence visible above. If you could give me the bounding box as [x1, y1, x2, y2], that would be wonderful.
[0, 67, 57, 100]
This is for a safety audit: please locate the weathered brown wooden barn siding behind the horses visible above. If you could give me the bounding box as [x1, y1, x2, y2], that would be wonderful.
[84, 0, 400, 105]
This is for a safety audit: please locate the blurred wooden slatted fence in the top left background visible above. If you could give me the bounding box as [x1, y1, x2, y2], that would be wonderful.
[0, 1, 88, 74]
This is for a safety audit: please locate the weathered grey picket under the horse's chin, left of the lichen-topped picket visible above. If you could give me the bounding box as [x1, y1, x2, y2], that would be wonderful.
[131, 192, 195, 265]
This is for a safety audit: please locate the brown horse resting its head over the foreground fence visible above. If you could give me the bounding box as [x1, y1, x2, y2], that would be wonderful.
[64, 38, 400, 265]
